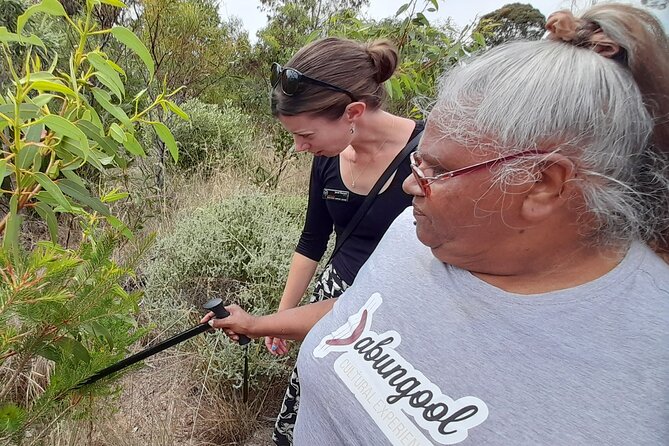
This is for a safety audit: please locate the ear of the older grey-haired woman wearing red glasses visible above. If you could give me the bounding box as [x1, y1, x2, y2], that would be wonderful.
[521, 154, 576, 222]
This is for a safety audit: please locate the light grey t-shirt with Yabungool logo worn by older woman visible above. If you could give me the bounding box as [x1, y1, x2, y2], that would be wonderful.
[295, 209, 669, 446]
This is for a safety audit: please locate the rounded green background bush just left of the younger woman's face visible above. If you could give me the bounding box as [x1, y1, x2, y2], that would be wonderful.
[172, 99, 252, 167]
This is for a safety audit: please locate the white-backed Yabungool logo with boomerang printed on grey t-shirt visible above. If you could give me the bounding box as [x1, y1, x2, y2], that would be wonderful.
[313, 293, 488, 445]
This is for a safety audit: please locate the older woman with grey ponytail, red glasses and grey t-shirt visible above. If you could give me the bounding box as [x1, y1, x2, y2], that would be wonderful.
[206, 5, 669, 445]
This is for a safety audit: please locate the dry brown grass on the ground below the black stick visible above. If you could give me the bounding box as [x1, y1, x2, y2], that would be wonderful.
[41, 352, 282, 446]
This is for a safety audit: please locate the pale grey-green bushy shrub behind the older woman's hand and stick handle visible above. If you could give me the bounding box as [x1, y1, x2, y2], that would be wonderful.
[144, 194, 306, 386]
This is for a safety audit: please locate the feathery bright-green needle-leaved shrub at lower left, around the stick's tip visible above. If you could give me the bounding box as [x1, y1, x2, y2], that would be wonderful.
[0, 230, 146, 444]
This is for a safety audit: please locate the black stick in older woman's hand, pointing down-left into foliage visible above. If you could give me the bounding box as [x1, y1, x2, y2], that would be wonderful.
[74, 298, 251, 389]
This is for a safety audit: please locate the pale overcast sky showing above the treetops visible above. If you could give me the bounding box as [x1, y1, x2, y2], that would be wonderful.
[219, 0, 669, 42]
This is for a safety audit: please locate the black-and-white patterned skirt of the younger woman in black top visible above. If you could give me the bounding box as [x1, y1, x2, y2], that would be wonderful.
[272, 264, 349, 446]
